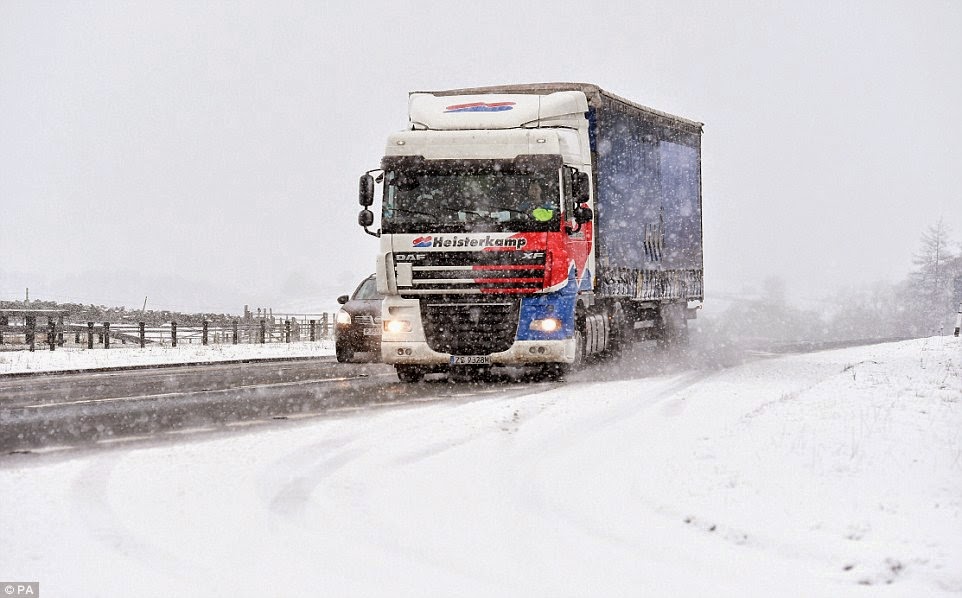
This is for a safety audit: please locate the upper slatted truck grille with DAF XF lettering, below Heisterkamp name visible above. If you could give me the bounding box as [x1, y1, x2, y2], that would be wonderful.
[396, 250, 545, 296]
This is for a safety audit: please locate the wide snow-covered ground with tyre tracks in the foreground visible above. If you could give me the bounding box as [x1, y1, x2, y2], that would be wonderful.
[0, 338, 962, 597]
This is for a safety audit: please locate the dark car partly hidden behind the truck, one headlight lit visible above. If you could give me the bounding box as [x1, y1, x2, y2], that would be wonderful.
[334, 274, 383, 363]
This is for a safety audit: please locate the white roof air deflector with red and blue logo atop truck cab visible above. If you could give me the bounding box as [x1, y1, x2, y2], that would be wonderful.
[408, 91, 588, 131]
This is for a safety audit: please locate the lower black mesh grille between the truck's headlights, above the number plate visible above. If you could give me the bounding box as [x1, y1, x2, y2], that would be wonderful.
[421, 297, 520, 355]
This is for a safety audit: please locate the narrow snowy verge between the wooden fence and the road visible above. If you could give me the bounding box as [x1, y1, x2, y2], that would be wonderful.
[0, 340, 334, 374]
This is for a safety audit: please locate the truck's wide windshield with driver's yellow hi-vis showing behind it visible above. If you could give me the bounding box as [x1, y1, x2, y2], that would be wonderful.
[382, 170, 560, 233]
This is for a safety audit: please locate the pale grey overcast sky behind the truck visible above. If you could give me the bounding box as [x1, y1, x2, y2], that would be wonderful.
[0, 0, 962, 313]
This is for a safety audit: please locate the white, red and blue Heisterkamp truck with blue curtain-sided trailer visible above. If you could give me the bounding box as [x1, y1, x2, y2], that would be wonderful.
[358, 83, 704, 382]
